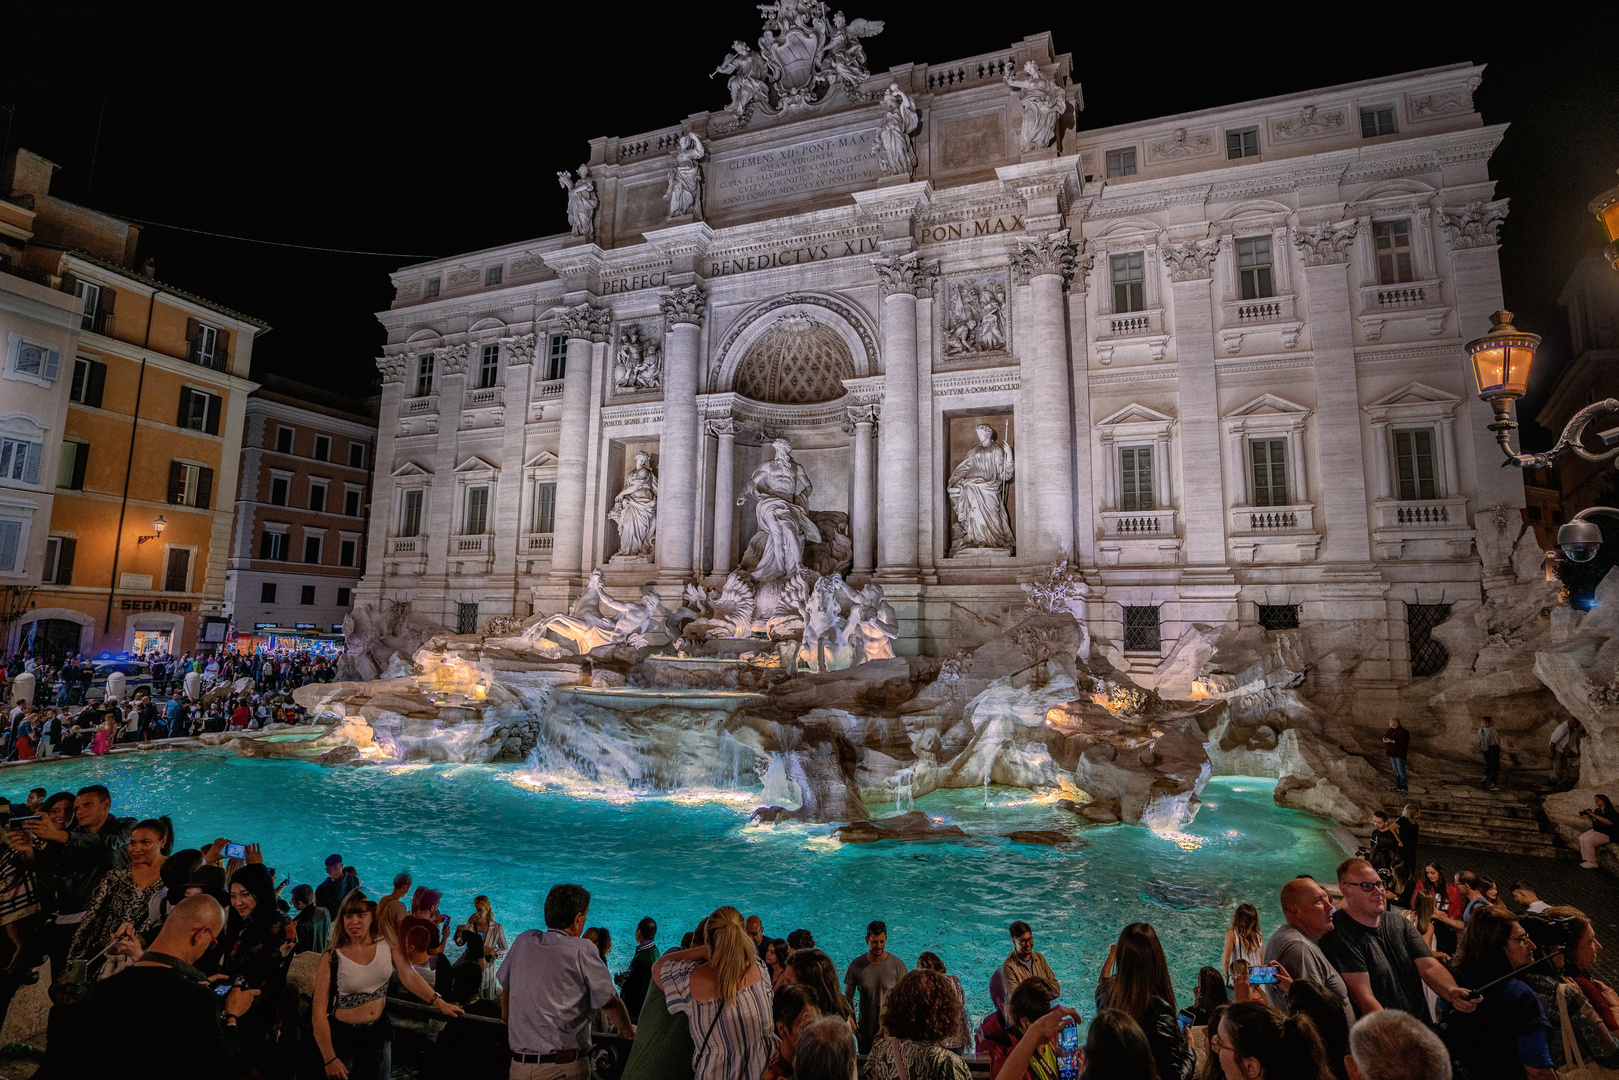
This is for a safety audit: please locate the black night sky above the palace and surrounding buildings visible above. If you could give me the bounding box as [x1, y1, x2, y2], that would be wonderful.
[0, 0, 1619, 440]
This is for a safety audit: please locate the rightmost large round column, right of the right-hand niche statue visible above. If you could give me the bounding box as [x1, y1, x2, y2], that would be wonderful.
[1012, 228, 1078, 563]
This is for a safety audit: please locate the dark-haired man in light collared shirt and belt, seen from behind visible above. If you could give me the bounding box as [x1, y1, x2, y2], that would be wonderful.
[497, 886, 635, 1080]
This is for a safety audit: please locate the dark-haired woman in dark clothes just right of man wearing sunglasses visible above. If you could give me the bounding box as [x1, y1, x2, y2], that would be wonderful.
[1439, 904, 1556, 1080]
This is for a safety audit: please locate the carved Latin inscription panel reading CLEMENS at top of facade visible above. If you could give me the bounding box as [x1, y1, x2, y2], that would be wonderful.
[704, 130, 879, 210]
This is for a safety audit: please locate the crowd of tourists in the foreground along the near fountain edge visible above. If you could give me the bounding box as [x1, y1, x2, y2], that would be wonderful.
[0, 785, 1593, 1080]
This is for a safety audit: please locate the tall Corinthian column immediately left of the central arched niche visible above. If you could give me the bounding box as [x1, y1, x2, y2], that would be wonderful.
[657, 285, 708, 581]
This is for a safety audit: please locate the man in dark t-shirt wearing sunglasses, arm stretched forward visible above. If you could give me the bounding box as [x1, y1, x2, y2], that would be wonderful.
[1321, 858, 1478, 1020]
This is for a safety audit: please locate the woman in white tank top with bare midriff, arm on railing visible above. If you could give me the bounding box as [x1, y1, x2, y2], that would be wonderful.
[311, 889, 461, 1080]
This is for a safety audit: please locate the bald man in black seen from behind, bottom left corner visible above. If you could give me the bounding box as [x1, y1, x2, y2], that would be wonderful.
[45, 895, 259, 1080]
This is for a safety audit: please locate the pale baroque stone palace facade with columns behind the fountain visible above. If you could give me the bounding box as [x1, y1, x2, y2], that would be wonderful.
[356, 23, 1523, 708]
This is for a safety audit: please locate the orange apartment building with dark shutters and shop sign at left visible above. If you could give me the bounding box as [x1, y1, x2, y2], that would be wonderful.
[0, 151, 269, 656]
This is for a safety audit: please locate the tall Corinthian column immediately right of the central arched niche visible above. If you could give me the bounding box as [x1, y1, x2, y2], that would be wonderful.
[856, 251, 939, 580]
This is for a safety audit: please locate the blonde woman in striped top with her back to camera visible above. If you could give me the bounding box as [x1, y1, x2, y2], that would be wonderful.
[652, 907, 780, 1080]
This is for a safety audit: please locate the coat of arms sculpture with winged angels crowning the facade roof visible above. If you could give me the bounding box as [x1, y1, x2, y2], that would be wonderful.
[709, 0, 882, 126]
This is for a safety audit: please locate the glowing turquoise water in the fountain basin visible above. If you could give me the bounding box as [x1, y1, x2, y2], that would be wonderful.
[0, 751, 1342, 1014]
